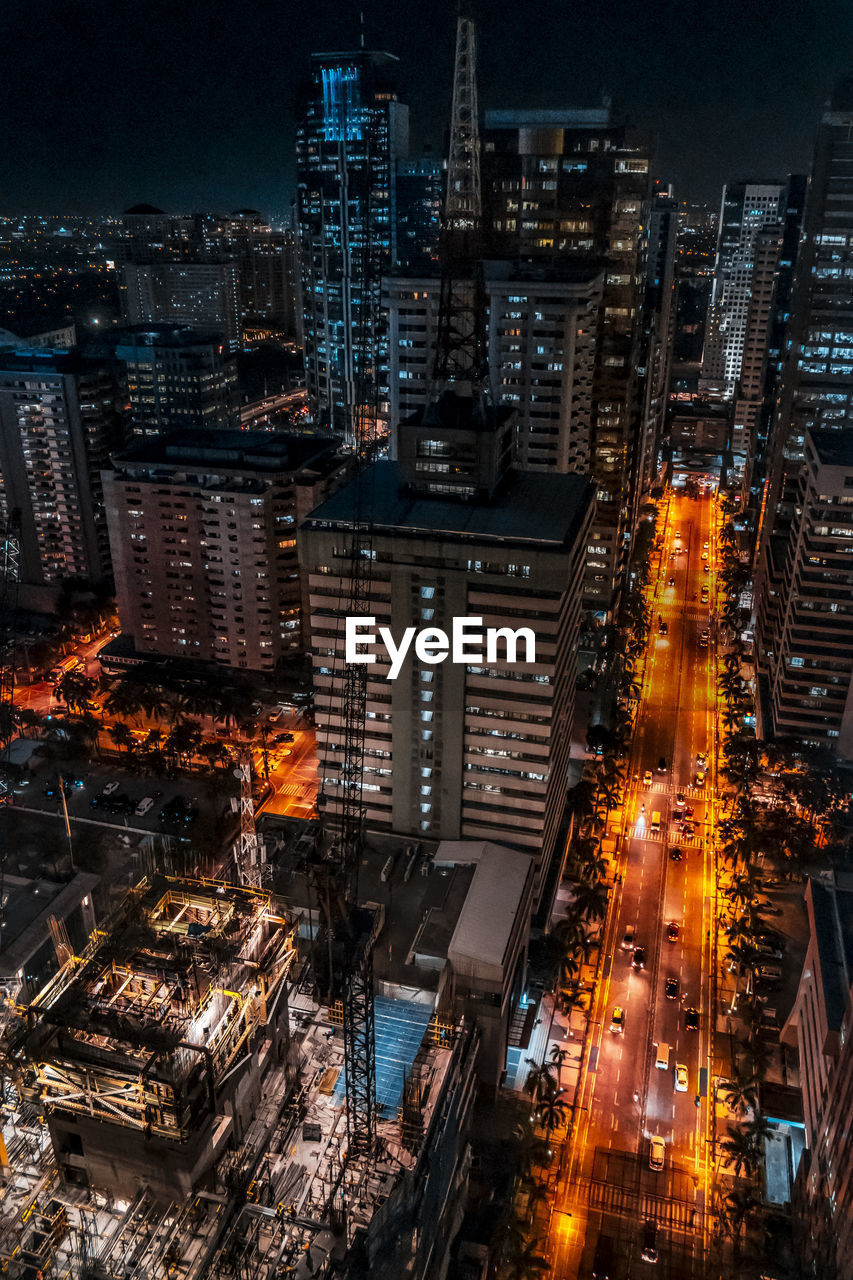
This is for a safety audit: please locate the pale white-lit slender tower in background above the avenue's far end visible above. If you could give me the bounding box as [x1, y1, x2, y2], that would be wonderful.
[702, 182, 785, 399]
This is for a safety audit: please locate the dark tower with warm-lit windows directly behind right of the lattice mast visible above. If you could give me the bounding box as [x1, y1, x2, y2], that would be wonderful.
[482, 105, 648, 613]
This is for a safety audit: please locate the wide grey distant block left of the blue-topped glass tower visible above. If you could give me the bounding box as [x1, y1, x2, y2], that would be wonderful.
[119, 260, 241, 355]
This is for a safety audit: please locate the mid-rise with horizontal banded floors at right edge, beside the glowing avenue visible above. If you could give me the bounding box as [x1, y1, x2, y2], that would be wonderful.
[758, 430, 853, 758]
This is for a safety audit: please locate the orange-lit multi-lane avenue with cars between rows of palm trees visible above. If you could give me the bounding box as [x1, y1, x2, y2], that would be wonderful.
[549, 483, 716, 1280]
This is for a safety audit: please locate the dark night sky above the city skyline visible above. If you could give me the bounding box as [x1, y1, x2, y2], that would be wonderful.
[0, 0, 853, 214]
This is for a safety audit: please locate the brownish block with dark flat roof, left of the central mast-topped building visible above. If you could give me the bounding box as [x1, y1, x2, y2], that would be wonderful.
[104, 430, 342, 672]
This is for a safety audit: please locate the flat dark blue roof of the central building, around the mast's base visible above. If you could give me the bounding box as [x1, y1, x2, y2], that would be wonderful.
[302, 462, 592, 548]
